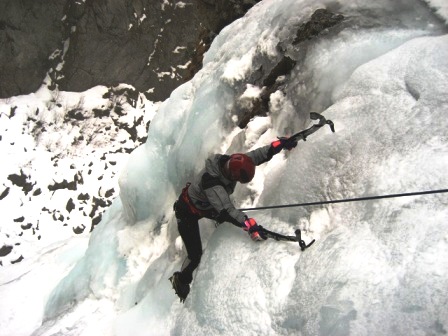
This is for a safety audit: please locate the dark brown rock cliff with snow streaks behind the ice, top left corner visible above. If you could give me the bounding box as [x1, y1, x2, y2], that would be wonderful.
[0, 0, 259, 100]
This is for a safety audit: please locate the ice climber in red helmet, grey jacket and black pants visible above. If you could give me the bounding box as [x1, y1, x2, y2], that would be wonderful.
[170, 138, 297, 302]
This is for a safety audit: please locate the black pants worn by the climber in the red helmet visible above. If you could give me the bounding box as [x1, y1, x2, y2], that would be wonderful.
[174, 197, 202, 284]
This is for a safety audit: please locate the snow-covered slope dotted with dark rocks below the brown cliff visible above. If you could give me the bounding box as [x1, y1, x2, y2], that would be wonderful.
[0, 85, 157, 263]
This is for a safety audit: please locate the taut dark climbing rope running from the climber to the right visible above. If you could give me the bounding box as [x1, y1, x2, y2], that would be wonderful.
[239, 189, 448, 211]
